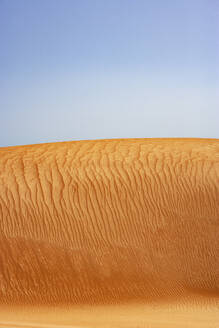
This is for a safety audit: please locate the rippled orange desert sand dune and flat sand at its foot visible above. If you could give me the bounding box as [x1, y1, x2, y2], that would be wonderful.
[0, 139, 219, 328]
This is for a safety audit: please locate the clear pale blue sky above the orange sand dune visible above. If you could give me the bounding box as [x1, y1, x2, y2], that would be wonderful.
[0, 0, 219, 146]
